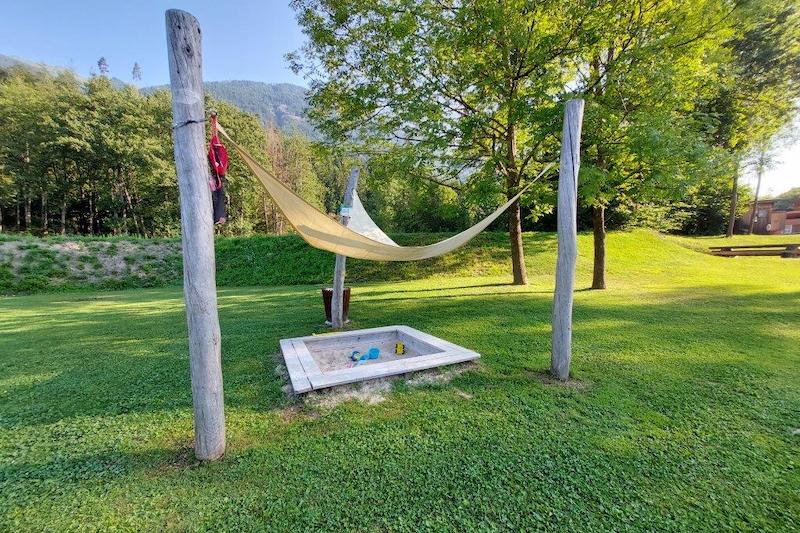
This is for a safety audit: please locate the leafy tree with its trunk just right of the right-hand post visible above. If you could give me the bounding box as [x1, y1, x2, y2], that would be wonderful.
[578, 0, 731, 289]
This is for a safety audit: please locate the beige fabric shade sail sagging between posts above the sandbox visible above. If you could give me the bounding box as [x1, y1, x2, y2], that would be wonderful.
[218, 122, 549, 261]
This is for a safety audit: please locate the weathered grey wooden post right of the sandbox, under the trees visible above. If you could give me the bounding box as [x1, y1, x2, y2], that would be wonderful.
[550, 100, 583, 381]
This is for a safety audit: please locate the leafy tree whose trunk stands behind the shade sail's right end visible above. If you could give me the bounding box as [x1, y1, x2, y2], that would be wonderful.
[289, 0, 594, 284]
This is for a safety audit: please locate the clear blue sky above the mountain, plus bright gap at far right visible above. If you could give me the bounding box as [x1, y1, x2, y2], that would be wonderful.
[0, 0, 800, 194]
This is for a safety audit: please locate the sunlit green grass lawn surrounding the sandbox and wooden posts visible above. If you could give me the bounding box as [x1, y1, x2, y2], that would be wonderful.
[0, 232, 800, 531]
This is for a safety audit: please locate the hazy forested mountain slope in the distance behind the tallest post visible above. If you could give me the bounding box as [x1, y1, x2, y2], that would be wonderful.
[142, 80, 310, 137]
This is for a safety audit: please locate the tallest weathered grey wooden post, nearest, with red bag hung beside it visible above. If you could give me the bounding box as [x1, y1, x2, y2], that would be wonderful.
[166, 9, 225, 460]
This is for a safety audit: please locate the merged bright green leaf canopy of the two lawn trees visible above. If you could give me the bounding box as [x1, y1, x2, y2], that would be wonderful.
[289, 0, 800, 266]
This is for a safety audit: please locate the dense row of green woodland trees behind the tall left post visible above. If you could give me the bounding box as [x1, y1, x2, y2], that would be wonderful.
[0, 70, 338, 237]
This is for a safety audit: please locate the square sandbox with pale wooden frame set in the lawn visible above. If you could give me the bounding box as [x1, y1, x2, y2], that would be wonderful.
[281, 326, 480, 393]
